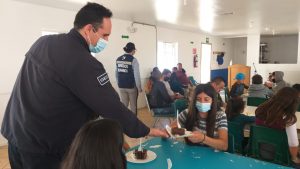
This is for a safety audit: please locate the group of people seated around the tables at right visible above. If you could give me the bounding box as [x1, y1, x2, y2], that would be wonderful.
[226, 71, 300, 165]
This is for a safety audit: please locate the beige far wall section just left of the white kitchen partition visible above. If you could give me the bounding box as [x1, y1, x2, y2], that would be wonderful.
[231, 38, 247, 65]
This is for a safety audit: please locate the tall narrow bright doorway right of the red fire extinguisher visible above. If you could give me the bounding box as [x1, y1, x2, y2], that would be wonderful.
[201, 43, 211, 83]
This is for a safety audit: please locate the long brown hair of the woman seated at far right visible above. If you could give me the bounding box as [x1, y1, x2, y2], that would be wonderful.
[255, 87, 299, 127]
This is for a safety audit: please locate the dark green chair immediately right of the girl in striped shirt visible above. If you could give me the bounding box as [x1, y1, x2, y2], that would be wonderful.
[227, 121, 245, 155]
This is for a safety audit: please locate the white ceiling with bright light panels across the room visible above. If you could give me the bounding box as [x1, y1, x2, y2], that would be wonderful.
[18, 0, 300, 37]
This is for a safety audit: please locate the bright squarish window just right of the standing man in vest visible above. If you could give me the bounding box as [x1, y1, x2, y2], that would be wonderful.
[157, 41, 178, 71]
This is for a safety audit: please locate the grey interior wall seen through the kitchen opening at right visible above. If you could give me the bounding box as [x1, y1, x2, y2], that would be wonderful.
[260, 35, 298, 64]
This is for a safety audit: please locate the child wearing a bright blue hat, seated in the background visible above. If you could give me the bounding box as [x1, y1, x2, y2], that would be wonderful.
[229, 73, 249, 97]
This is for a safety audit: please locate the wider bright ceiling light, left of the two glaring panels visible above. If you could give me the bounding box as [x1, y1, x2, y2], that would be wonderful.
[155, 0, 179, 23]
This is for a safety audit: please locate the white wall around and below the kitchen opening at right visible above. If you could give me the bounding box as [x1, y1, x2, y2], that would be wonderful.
[247, 34, 300, 84]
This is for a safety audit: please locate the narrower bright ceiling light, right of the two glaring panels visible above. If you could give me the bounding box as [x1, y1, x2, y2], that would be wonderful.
[199, 0, 214, 32]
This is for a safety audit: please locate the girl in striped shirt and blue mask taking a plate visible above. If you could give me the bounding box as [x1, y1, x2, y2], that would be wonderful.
[171, 84, 228, 151]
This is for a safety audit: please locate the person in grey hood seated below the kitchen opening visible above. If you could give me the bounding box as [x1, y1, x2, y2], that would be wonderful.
[267, 71, 289, 94]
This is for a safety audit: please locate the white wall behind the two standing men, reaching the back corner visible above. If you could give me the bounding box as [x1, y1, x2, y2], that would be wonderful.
[0, 0, 232, 145]
